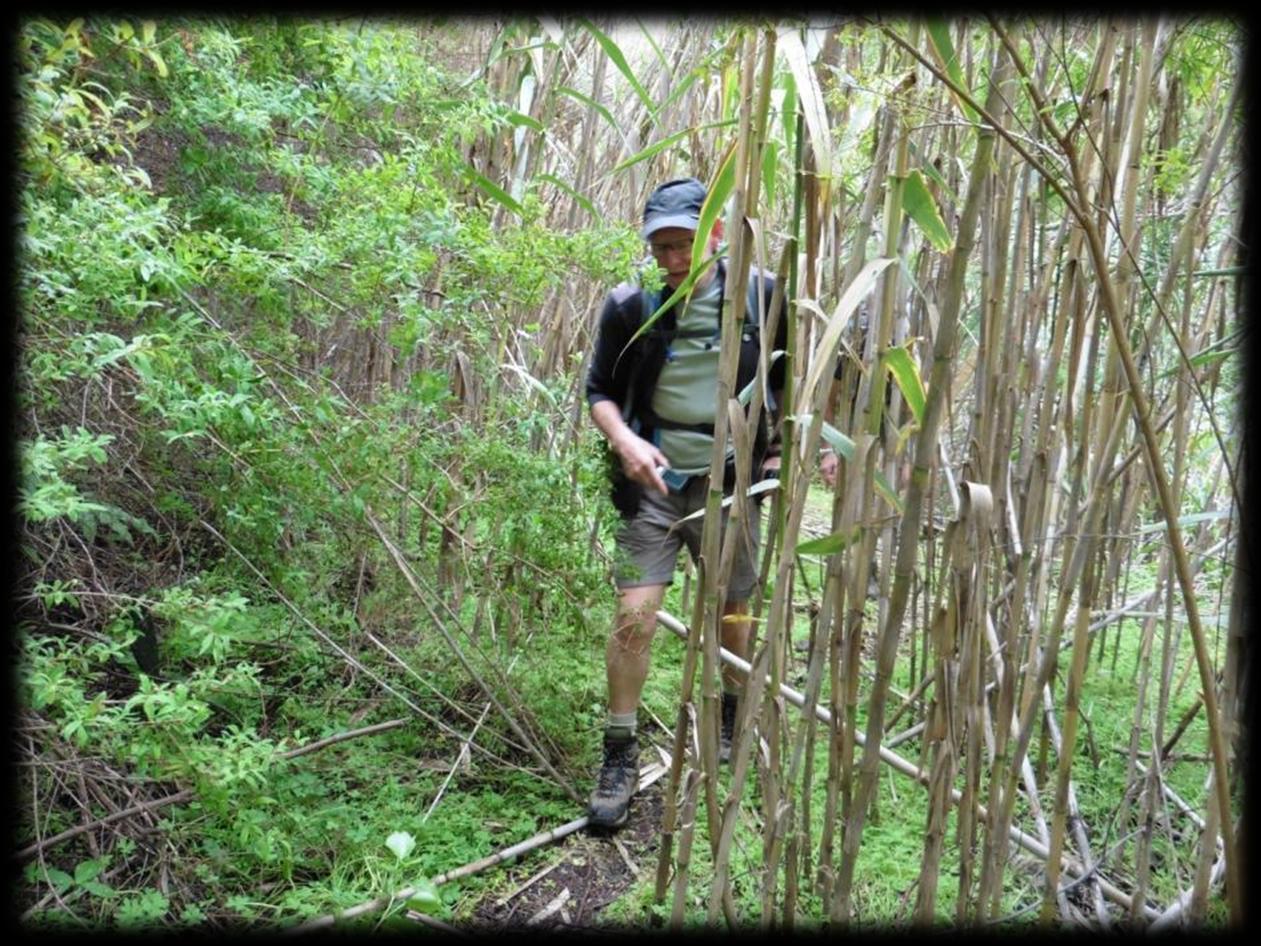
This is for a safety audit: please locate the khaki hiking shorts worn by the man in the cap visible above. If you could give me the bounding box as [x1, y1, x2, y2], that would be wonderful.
[613, 476, 762, 600]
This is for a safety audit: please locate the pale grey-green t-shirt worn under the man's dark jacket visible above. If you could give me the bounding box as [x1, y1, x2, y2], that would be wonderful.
[652, 279, 735, 474]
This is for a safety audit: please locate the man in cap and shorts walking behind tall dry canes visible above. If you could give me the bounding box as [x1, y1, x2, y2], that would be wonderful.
[586, 178, 835, 827]
